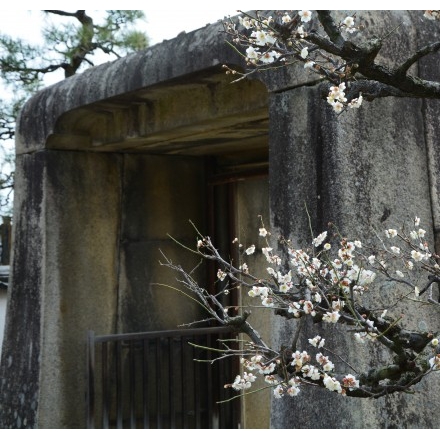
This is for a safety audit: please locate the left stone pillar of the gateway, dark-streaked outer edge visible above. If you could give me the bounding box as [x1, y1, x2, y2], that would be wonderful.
[0, 151, 120, 428]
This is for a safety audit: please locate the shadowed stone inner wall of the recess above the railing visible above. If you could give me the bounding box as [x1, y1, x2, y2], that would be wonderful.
[118, 155, 205, 333]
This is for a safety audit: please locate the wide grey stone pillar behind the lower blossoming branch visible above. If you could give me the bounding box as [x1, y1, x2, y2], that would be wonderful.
[269, 87, 440, 428]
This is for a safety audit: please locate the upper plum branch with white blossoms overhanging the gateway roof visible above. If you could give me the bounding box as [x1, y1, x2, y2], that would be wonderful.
[224, 10, 440, 113]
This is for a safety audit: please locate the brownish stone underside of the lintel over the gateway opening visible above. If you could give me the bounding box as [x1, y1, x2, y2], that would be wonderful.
[46, 71, 269, 165]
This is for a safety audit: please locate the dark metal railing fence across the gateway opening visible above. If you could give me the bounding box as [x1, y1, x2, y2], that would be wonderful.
[87, 328, 240, 429]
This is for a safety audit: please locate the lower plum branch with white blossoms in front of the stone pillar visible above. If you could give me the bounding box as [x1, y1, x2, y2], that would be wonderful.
[162, 217, 440, 398]
